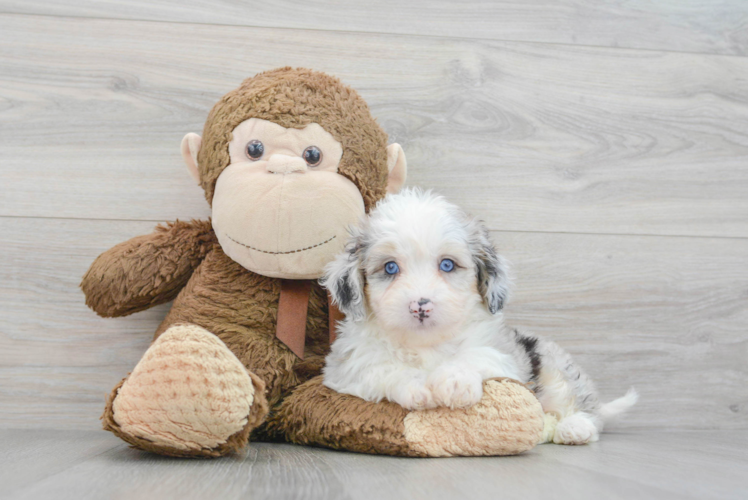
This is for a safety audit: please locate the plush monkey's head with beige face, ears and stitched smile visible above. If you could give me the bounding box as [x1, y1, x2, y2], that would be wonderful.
[182, 68, 406, 279]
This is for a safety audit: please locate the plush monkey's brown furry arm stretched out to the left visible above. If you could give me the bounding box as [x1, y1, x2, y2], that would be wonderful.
[81, 220, 216, 318]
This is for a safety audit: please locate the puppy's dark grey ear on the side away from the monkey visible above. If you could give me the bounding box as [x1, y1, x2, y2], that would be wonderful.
[470, 221, 509, 314]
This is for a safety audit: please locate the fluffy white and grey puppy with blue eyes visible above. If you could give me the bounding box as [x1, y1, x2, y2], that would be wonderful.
[323, 189, 637, 444]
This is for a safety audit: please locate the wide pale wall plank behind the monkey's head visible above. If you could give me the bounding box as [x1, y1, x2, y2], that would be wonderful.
[0, 13, 748, 237]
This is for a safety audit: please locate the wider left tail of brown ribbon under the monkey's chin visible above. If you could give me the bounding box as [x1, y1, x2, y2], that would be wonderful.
[275, 280, 312, 359]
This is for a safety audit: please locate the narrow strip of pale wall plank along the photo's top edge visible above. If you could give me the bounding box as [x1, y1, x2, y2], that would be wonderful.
[0, 0, 748, 55]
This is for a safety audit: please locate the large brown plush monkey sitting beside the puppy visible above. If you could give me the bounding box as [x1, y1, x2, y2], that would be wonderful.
[81, 68, 542, 457]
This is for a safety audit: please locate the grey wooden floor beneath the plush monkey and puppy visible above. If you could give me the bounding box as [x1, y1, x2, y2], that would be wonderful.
[0, 431, 748, 500]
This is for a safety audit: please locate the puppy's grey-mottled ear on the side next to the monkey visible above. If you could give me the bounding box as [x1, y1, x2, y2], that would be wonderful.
[320, 232, 366, 320]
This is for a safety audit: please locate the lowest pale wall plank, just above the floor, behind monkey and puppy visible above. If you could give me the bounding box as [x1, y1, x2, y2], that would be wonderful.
[0, 218, 748, 429]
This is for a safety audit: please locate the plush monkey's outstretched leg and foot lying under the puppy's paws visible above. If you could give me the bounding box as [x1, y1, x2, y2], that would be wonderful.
[268, 377, 543, 457]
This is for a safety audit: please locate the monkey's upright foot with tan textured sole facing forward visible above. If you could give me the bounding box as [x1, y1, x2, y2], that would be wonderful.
[102, 325, 268, 457]
